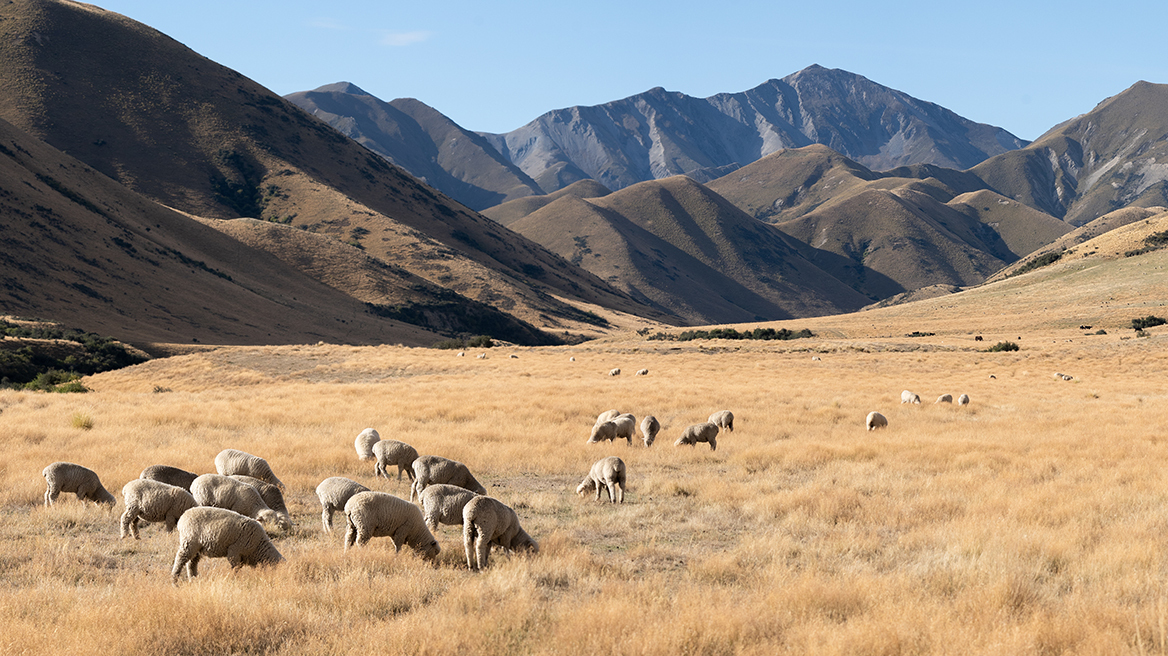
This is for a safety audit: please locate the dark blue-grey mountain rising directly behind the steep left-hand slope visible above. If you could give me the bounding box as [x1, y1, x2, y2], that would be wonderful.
[285, 82, 543, 210]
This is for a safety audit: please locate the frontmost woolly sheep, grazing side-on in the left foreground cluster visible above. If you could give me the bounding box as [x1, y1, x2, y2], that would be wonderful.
[171, 507, 284, 584]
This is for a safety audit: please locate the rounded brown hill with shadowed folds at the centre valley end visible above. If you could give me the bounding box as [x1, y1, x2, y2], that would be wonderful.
[510, 176, 869, 323]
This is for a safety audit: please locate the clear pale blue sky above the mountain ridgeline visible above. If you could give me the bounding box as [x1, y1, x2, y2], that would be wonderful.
[93, 0, 1168, 140]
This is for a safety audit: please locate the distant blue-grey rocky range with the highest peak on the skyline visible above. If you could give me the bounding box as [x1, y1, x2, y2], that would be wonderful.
[484, 65, 1027, 193]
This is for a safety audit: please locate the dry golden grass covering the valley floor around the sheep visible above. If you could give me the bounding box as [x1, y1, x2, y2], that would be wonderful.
[0, 328, 1168, 655]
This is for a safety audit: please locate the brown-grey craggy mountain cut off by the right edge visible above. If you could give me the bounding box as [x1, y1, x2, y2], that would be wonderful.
[971, 82, 1168, 225]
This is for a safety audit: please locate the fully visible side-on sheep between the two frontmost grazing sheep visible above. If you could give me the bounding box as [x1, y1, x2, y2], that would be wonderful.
[345, 491, 440, 560]
